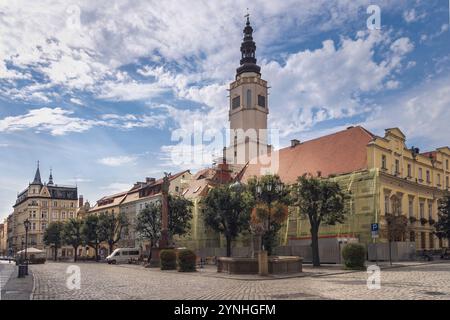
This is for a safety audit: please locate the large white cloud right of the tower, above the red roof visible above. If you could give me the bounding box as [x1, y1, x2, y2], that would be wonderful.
[262, 33, 413, 135]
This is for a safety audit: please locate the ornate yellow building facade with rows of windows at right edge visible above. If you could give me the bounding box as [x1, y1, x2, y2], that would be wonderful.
[367, 128, 450, 250]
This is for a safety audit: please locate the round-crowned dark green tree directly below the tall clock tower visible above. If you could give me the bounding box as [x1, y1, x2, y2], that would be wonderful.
[202, 184, 253, 257]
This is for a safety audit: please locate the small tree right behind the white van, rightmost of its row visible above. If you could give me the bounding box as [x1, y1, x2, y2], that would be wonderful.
[98, 212, 128, 254]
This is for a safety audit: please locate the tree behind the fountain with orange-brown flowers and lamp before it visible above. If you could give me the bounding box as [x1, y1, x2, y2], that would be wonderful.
[248, 174, 290, 255]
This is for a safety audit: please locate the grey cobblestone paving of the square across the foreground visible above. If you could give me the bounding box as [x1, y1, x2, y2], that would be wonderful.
[31, 262, 450, 300]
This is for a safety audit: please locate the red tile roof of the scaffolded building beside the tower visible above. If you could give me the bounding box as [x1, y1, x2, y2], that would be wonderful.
[241, 126, 375, 183]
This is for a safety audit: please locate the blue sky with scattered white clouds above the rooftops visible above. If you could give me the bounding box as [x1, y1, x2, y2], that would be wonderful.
[0, 0, 450, 218]
